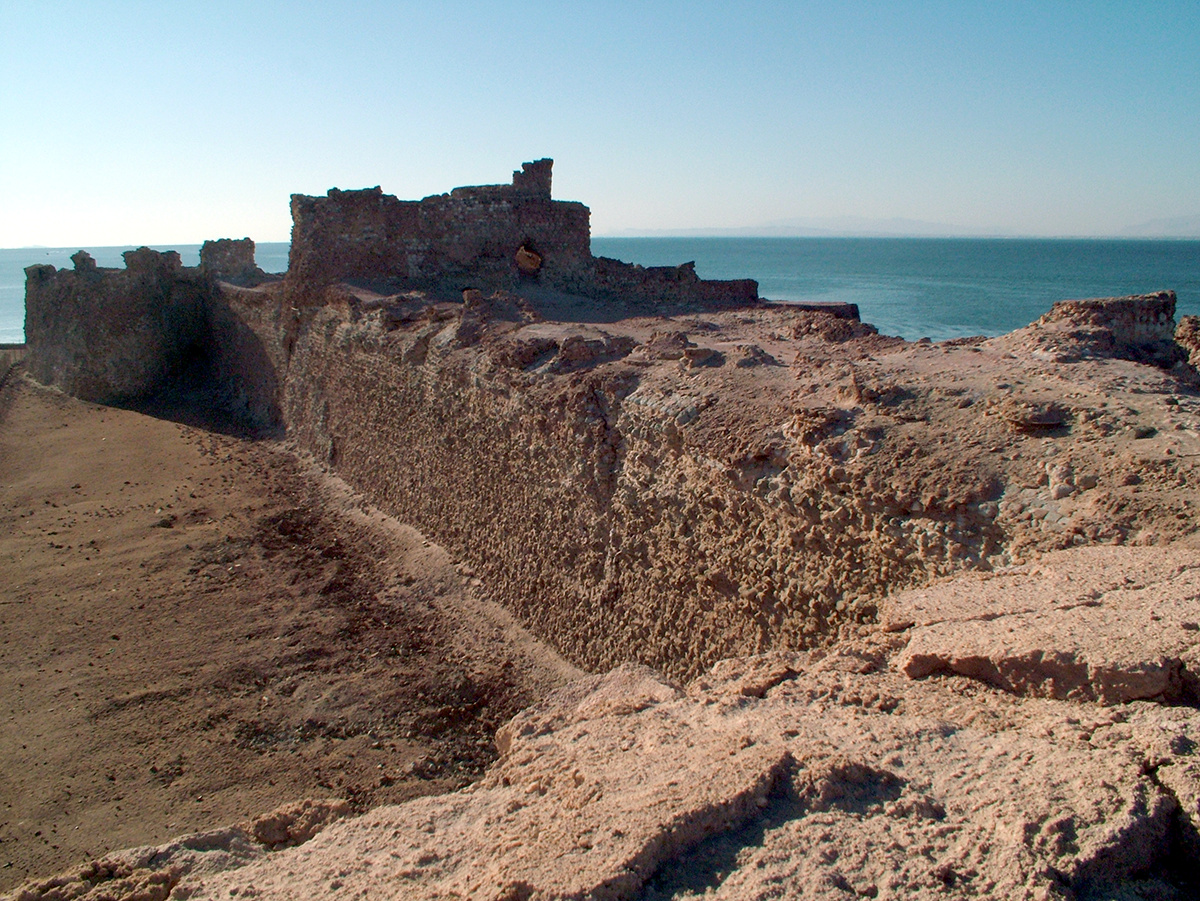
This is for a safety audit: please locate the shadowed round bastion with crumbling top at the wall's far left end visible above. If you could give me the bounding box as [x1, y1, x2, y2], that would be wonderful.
[22, 244, 286, 428]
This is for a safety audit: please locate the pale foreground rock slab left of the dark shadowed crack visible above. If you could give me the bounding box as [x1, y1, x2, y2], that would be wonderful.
[175, 669, 791, 899]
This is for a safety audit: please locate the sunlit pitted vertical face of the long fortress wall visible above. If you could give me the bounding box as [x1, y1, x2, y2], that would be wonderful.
[267, 299, 995, 678]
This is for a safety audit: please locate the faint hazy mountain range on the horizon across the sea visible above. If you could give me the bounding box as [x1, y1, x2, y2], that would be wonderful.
[596, 216, 1200, 239]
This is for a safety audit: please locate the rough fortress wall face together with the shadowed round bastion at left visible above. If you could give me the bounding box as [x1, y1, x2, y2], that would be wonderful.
[21, 244, 1190, 678]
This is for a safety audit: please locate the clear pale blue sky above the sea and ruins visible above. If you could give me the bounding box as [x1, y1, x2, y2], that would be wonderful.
[0, 0, 1200, 247]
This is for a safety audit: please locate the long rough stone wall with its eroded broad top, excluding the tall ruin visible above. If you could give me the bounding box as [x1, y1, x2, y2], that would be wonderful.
[250, 292, 1200, 678]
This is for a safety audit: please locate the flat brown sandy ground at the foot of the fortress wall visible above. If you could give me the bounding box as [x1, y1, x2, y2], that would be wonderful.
[0, 371, 580, 891]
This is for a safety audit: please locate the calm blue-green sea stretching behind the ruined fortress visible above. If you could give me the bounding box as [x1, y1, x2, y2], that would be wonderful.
[0, 238, 1200, 343]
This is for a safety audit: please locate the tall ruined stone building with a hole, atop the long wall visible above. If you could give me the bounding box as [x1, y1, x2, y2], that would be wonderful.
[288, 160, 758, 306]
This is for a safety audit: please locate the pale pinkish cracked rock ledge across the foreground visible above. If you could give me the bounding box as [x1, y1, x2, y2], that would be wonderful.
[9, 542, 1200, 900]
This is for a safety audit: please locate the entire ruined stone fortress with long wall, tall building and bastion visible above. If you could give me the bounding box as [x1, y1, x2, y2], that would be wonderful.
[18, 160, 1200, 675]
